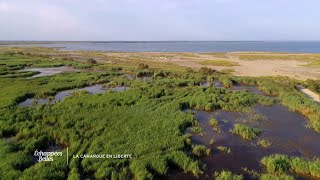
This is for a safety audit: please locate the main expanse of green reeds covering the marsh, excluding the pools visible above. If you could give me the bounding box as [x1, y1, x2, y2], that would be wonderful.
[0, 48, 320, 179]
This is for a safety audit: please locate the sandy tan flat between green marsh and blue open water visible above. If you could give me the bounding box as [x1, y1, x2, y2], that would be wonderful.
[0, 47, 320, 80]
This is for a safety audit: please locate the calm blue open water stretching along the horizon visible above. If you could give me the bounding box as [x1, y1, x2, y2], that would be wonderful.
[1, 41, 320, 53]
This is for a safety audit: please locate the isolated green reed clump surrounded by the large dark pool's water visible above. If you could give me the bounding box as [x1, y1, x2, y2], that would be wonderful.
[230, 124, 262, 140]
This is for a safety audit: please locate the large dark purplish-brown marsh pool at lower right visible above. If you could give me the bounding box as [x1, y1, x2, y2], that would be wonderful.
[165, 105, 320, 179]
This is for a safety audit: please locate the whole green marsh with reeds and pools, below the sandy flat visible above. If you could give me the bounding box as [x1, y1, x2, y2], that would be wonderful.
[0, 47, 320, 180]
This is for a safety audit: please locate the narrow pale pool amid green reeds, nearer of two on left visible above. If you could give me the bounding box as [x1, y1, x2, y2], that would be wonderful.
[19, 84, 128, 106]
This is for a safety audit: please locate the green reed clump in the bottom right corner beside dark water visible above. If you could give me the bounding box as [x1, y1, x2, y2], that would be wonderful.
[261, 154, 320, 178]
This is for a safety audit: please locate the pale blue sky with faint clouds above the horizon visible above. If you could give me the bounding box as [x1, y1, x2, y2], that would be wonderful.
[0, 0, 320, 41]
